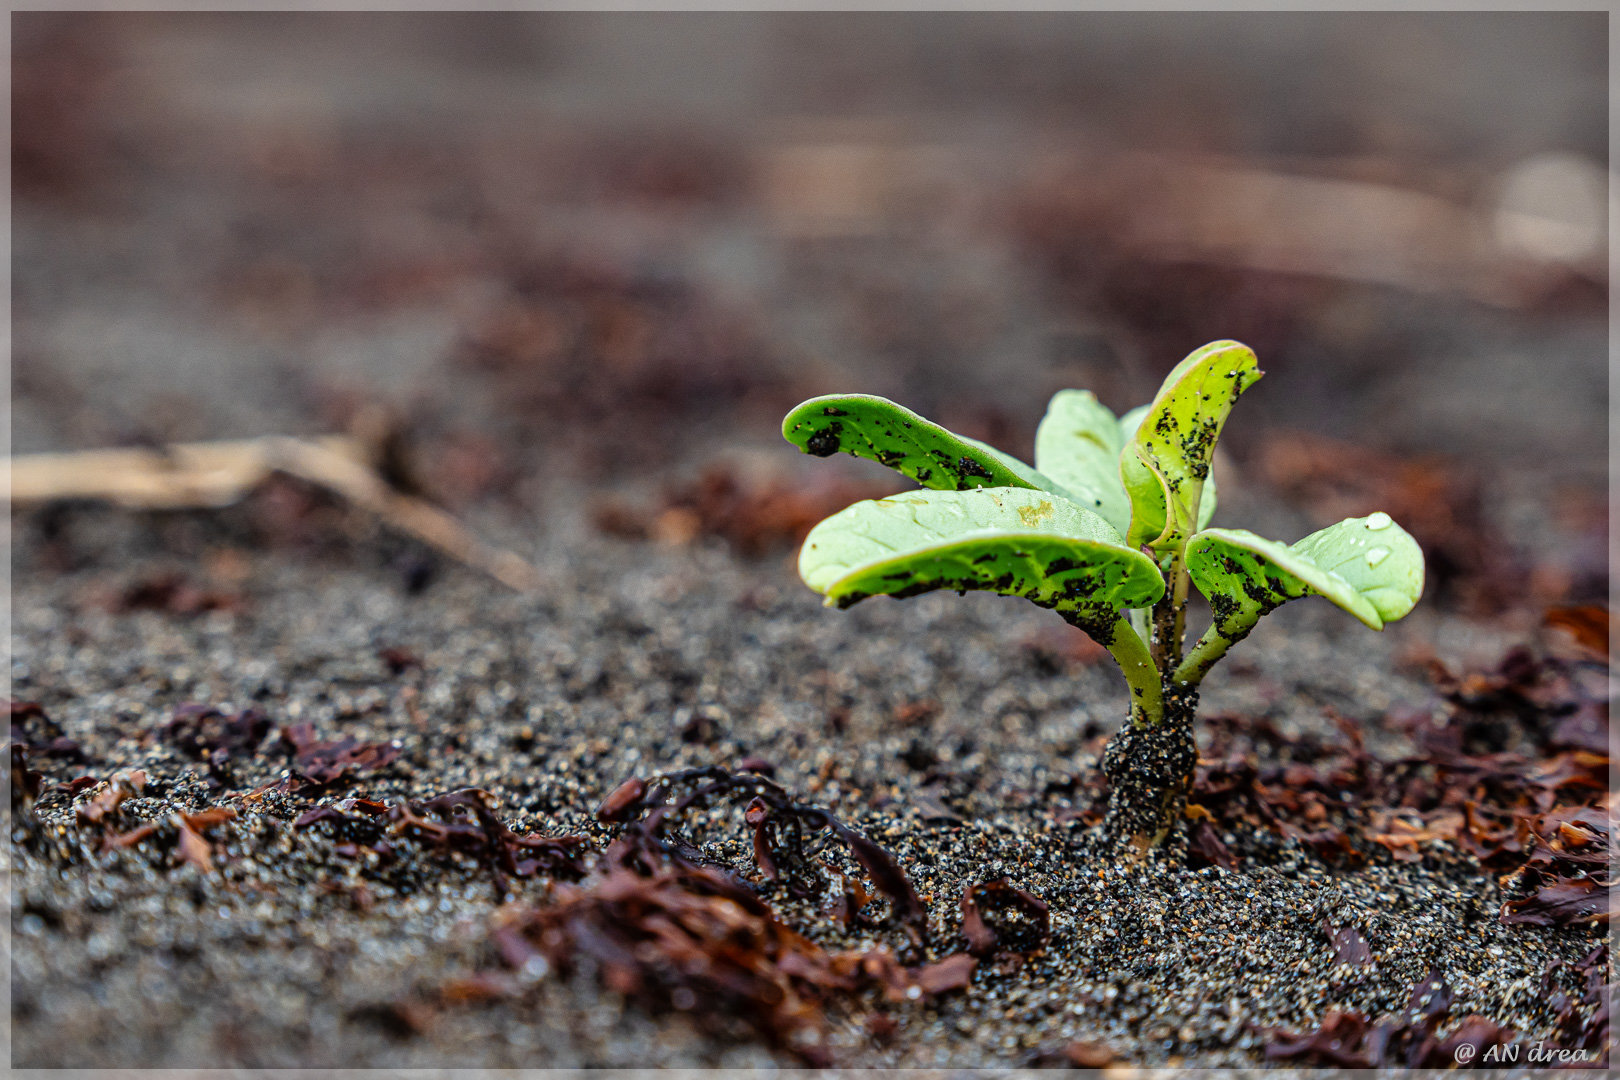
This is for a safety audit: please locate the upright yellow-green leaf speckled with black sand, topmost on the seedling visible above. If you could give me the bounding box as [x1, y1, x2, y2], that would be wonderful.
[1119, 342, 1264, 549]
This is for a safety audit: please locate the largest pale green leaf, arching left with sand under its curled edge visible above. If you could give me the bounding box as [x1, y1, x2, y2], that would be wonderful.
[799, 487, 1165, 630]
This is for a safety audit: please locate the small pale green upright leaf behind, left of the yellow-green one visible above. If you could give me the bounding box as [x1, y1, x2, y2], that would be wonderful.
[1035, 390, 1131, 533]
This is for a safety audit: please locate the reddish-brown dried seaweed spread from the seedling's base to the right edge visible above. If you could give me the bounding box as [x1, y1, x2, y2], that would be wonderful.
[1187, 634, 1610, 893]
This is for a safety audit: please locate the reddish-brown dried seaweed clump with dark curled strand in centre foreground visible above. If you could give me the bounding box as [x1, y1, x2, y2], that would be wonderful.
[456, 767, 984, 1065]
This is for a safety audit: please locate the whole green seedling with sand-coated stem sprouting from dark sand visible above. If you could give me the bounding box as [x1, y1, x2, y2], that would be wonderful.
[782, 342, 1424, 855]
